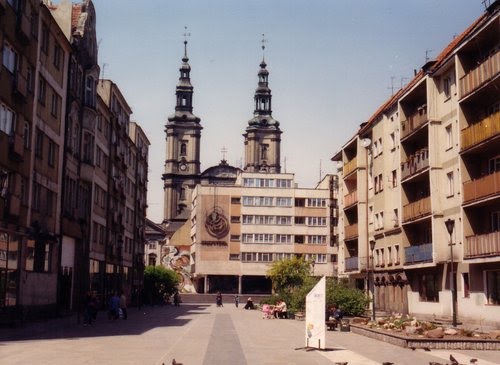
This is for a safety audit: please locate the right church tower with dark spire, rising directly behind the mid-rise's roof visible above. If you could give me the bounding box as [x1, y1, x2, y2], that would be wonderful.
[243, 40, 282, 173]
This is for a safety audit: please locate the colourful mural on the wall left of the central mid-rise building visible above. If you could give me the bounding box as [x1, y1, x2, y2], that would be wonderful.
[161, 245, 196, 293]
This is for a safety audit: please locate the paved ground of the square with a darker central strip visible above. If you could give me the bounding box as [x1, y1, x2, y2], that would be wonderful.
[0, 304, 500, 365]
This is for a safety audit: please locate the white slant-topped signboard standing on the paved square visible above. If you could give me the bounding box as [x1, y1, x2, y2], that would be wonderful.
[306, 276, 326, 349]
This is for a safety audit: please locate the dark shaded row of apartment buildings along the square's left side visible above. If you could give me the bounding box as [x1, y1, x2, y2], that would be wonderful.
[0, 0, 149, 322]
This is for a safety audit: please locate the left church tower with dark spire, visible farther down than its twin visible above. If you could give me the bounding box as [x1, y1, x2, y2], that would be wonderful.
[162, 38, 203, 223]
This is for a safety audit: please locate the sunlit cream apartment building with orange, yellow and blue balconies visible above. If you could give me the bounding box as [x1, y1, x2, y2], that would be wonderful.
[332, 1, 500, 325]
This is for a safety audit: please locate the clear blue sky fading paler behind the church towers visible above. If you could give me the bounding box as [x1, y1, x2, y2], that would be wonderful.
[93, 0, 484, 222]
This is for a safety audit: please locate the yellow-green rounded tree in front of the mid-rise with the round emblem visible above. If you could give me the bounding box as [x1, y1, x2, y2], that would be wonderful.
[266, 256, 311, 295]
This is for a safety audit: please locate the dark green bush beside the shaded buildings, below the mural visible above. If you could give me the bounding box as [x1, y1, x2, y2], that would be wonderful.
[144, 266, 179, 304]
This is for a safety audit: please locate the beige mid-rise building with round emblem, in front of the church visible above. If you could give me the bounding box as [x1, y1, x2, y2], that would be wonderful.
[190, 172, 337, 294]
